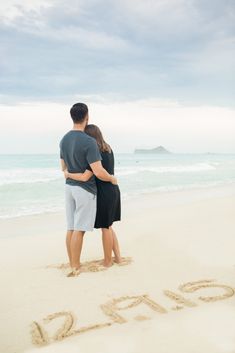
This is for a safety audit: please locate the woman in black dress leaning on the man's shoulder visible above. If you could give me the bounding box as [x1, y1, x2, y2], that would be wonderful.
[65, 124, 122, 267]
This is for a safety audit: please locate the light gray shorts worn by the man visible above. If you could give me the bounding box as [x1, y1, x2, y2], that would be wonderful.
[65, 184, 96, 232]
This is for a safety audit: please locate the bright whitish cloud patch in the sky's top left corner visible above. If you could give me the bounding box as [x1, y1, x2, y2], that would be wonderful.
[0, 0, 128, 50]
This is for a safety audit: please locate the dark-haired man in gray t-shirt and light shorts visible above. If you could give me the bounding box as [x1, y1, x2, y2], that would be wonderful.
[60, 103, 117, 276]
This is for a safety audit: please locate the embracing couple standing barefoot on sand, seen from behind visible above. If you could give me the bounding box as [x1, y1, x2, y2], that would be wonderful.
[60, 103, 122, 276]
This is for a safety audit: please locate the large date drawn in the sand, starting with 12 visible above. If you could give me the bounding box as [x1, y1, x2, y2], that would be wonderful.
[31, 280, 235, 346]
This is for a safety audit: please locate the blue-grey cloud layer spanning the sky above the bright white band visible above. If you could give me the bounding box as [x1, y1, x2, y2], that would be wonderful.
[0, 0, 235, 105]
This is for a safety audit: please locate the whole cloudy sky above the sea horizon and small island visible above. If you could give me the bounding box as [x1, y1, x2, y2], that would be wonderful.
[0, 0, 235, 153]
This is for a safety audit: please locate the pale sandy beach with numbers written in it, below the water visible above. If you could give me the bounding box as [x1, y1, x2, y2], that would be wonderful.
[0, 184, 235, 353]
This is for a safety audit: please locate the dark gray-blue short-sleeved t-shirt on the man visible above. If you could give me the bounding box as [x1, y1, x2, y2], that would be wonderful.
[60, 130, 102, 195]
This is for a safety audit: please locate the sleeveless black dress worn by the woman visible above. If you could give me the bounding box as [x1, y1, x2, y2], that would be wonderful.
[95, 151, 121, 228]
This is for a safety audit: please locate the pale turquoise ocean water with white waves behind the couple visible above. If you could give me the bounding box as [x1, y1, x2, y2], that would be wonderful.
[0, 154, 235, 219]
